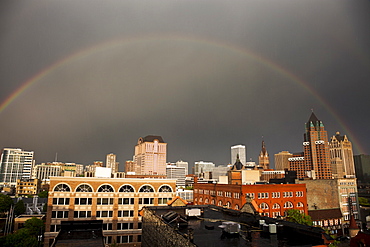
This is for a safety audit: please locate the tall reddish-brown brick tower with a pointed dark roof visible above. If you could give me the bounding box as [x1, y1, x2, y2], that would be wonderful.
[289, 112, 333, 179]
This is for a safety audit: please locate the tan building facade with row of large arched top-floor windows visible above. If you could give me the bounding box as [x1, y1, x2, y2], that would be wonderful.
[44, 177, 176, 246]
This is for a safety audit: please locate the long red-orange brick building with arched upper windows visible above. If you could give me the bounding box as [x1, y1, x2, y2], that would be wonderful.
[194, 183, 308, 218]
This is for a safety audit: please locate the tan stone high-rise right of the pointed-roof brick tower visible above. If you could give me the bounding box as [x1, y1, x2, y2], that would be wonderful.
[329, 132, 356, 178]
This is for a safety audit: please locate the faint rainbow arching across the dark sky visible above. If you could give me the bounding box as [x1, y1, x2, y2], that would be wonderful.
[0, 34, 366, 153]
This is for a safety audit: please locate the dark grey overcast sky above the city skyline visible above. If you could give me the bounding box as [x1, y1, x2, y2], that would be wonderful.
[0, 0, 370, 170]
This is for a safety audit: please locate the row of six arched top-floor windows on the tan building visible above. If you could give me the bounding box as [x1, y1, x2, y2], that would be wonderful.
[53, 184, 173, 193]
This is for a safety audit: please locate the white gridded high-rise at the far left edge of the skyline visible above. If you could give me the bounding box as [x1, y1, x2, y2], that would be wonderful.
[0, 148, 34, 186]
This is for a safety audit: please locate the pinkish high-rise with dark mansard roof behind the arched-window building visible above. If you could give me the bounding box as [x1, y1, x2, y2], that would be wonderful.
[134, 135, 167, 175]
